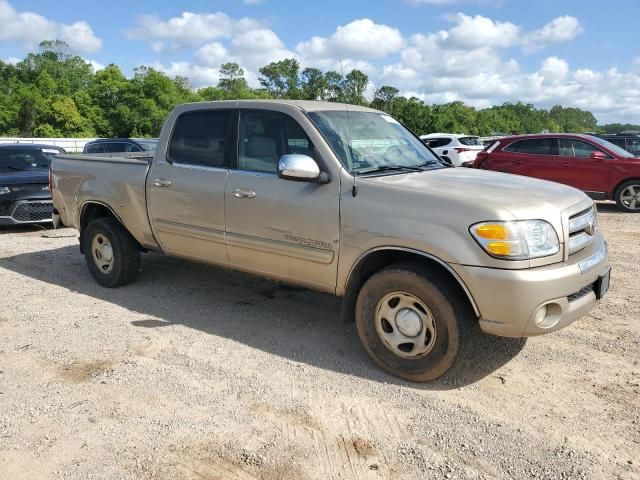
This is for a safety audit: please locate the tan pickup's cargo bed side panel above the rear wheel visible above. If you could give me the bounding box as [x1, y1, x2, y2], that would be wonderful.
[51, 153, 157, 249]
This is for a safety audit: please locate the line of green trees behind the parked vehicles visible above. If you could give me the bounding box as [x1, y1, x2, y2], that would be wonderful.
[0, 40, 640, 137]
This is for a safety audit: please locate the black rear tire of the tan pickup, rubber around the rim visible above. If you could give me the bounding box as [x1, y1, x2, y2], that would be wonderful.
[82, 217, 140, 288]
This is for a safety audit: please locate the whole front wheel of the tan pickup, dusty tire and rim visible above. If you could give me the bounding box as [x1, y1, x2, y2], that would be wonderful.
[356, 264, 471, 382]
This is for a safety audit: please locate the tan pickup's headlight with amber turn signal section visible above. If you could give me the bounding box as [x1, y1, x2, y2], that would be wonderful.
[469, 220, 560, 260]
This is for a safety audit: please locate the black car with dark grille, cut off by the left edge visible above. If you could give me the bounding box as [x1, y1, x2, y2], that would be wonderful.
[0, 144, 66, 225]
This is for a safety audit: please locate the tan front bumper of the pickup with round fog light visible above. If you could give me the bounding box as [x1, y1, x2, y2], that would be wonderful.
[451, 236, 610, 337]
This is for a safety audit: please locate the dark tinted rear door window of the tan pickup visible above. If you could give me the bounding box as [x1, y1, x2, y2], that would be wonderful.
[167, 110, 230, 168]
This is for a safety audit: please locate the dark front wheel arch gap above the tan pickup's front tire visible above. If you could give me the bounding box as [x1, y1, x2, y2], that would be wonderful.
[341, 247, 480, 323]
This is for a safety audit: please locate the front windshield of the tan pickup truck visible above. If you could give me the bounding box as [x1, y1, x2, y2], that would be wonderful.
[309, 110, 445, 175]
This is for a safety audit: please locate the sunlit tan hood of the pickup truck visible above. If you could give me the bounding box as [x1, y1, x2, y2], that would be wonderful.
[362, 168, 592, 219]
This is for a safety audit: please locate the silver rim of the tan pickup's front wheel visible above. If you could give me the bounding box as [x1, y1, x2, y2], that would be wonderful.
[376, 291, 436, 359]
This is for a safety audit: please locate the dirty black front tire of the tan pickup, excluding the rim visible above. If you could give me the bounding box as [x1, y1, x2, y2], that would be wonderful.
[356, 264, 479, 382]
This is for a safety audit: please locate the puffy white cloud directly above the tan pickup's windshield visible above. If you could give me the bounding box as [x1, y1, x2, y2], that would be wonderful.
[296, 18, 404, 63]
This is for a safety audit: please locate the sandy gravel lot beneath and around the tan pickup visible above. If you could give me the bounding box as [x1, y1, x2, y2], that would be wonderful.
[0, 205, 640, 480]
